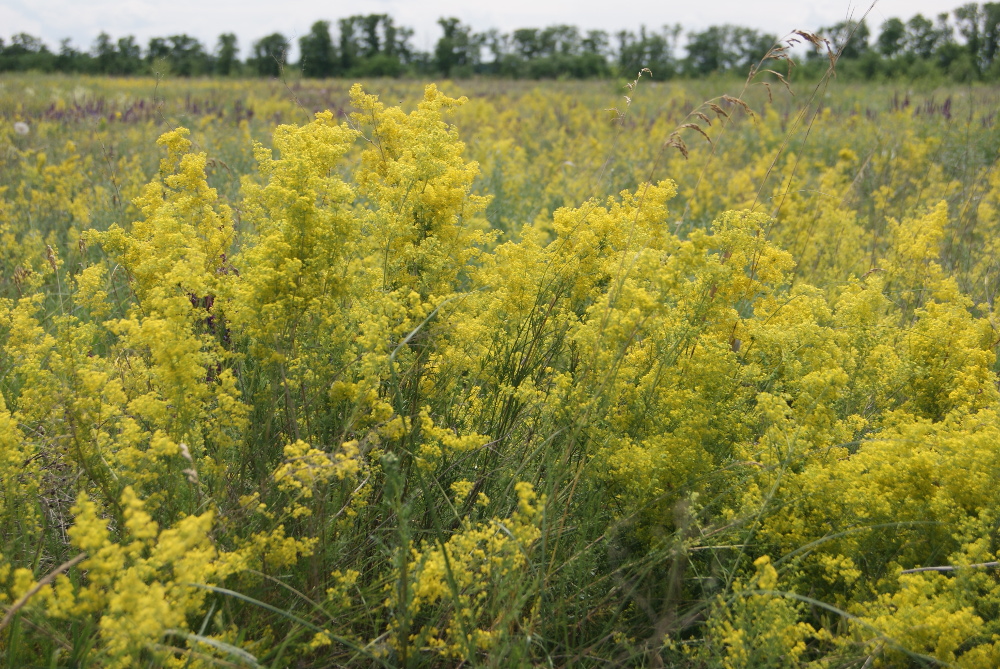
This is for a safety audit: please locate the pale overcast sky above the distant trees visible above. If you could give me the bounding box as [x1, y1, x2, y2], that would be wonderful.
[0, 0, 967, 56]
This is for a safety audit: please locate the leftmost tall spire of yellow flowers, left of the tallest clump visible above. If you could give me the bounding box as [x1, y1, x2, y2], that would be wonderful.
[91, 129, 245, 500]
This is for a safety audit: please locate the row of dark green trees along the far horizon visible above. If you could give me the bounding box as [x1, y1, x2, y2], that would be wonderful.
[0, 2, 1000, 81]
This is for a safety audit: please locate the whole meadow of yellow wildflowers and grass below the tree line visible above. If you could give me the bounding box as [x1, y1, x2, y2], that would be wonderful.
[0, 70, 1000, 669]
